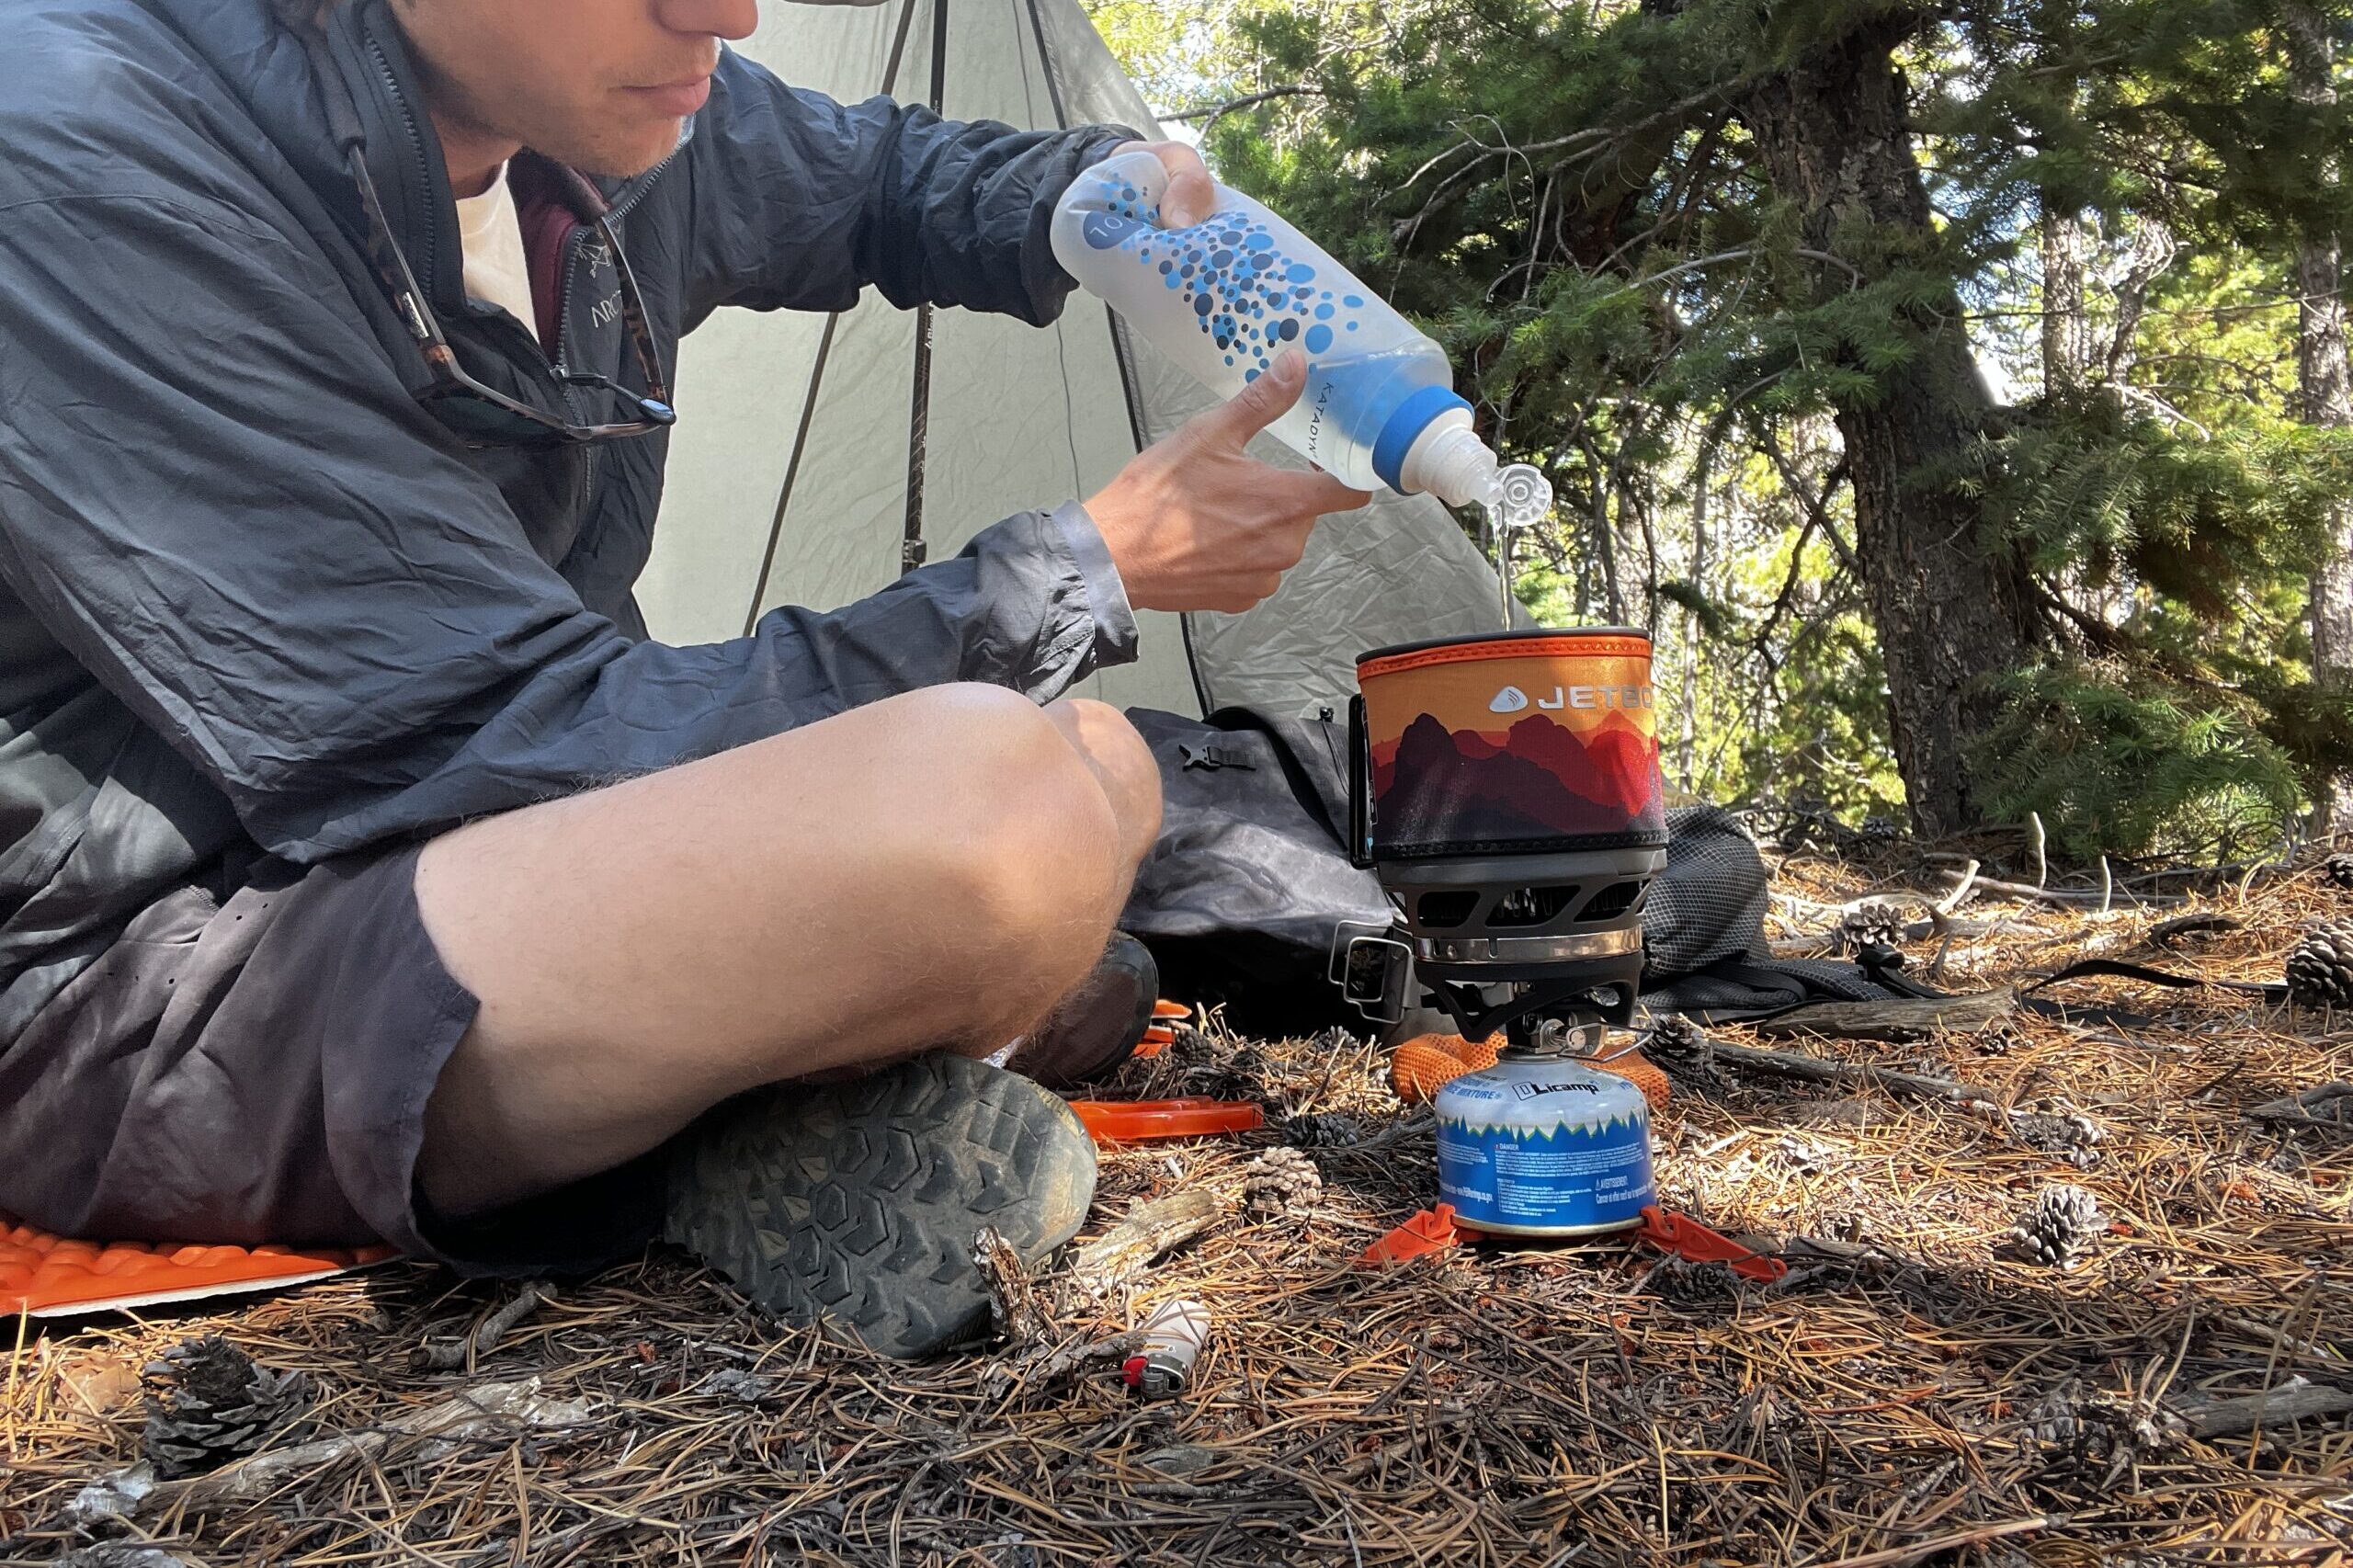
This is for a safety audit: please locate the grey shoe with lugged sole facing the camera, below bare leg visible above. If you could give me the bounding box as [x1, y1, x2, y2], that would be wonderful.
[664, 1055, 1094, 1361]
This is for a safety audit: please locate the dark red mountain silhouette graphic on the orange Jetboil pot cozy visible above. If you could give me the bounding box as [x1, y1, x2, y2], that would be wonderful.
[1371, 713, 1661, 846]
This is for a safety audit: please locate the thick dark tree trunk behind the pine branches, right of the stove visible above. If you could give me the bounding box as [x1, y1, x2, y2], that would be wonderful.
[1741, 18, 2040, 834]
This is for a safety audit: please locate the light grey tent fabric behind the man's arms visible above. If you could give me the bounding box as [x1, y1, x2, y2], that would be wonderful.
[638, 0, 1496, 713]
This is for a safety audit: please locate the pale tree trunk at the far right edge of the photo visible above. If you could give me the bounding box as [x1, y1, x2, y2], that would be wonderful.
[2282, 0, 2353, 834]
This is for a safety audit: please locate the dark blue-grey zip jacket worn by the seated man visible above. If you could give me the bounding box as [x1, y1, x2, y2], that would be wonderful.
[0, 0, 1134, 1026]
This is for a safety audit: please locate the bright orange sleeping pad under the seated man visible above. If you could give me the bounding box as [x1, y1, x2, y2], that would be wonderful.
[0, 1215, 393, 1318]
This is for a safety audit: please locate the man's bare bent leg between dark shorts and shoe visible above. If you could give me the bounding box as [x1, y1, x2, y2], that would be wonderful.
[416, 685, 1160, 1215]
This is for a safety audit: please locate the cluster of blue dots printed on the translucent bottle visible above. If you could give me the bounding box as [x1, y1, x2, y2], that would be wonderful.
[1080, 181, 1365, 381]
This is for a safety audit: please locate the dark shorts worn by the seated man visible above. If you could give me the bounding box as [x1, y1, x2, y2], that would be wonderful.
[0, 847, 659, 1274]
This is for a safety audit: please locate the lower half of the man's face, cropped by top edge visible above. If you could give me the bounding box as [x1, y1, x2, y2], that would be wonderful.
[393, 0, 760, 175]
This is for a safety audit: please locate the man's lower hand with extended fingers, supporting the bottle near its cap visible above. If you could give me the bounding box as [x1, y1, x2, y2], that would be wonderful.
[1087, 348, 1371, 612]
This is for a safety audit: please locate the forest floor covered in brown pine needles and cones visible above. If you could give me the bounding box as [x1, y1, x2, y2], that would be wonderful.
[0, 846, 2353, 1568]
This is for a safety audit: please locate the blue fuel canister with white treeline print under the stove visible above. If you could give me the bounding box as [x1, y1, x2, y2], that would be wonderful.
[1438, 1062, 1656, 1236]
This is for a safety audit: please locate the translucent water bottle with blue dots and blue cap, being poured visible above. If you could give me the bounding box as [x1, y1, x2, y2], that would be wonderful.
[1051, 153, 1553, 515]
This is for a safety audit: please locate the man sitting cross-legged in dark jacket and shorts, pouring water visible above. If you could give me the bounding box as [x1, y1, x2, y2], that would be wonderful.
[0, 0, 1365, 1354]
